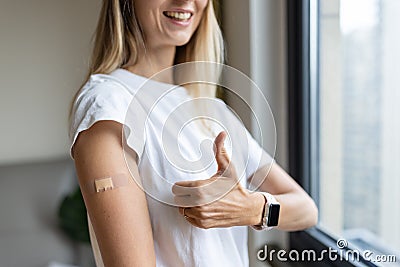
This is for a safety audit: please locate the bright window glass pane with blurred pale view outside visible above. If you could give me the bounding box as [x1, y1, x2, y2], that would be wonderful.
[318, 0, 400, 255]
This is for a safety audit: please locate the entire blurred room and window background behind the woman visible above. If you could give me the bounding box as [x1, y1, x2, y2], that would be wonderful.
[0, 0, 400, 267]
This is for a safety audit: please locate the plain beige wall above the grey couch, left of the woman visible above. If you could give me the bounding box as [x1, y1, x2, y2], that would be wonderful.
[0, 0, 101, 164]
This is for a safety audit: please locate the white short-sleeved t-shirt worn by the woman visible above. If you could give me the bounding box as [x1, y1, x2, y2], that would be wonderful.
[70, 69, 272, 267]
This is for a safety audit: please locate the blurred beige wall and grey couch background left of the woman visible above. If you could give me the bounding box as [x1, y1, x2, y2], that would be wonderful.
[0, 0, 101, 267]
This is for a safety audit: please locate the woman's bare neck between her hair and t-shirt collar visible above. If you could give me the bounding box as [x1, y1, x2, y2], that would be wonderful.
[126, 46, 176, 83]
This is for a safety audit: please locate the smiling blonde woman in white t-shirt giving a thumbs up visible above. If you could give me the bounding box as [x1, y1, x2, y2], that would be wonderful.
[70, 0, 317, 266]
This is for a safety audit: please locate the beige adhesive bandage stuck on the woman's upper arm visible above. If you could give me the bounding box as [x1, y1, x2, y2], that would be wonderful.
[86, 174, 129, 194]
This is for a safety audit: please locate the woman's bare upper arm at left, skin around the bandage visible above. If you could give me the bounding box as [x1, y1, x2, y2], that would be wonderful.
[73, 121, 155, 266]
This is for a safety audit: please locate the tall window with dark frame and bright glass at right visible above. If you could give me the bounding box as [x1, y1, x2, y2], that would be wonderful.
[288, 0, 400, 266]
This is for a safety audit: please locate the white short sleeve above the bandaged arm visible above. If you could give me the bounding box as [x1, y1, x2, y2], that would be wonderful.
[69, 76, 144, 158]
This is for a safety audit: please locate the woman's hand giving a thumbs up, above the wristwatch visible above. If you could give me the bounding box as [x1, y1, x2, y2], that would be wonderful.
[172, 132, 265, 229]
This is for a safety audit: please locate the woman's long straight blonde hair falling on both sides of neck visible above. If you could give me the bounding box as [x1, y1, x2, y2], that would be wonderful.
[77, 0, 224, 96]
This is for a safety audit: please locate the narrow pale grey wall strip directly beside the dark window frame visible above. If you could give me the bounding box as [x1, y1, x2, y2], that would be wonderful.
[249, 0, 288, 267]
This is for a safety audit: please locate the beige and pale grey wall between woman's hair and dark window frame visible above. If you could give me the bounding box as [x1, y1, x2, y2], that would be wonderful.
[222, 0, 287, 267]
